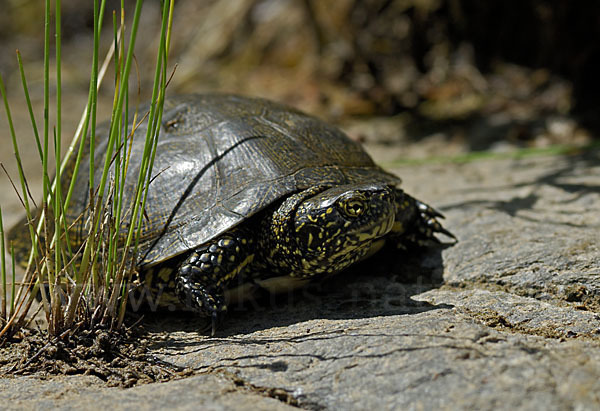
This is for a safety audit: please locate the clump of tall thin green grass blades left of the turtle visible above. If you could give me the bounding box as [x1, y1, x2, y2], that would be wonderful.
[0, 0, 174, 343]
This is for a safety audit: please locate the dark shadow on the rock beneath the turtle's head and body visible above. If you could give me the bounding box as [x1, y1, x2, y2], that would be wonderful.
[145, 246, 447, 338]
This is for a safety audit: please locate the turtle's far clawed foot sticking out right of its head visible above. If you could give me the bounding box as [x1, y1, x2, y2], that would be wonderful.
[390, 189, 458, 248]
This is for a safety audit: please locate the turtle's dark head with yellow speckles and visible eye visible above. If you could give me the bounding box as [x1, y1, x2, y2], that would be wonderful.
[288, 184, 395, 276]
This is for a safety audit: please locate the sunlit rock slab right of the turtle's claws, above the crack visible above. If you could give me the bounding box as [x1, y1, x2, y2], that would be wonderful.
[422, 151, 600, 305]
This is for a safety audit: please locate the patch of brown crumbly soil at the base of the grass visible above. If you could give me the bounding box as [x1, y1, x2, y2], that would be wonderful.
[0, 327, 191, 388]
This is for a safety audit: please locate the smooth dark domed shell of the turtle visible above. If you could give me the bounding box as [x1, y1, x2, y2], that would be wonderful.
[67, 95, 400, 266]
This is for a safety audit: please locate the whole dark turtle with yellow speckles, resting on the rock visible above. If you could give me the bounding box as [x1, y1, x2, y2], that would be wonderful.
[9, 94, 455, 334]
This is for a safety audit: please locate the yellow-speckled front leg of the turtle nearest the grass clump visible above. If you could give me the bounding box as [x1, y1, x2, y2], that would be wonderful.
[176, 229, 254, 335]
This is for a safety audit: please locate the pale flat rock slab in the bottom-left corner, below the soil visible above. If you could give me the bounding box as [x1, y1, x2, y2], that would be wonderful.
[0, 375, 293, 411]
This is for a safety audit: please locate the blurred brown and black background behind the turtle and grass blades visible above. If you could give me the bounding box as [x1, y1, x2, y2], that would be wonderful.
[0, 0, 600, 179]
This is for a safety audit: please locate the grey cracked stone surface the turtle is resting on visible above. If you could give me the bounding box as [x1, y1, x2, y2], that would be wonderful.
[0, 146, 600, 410]
